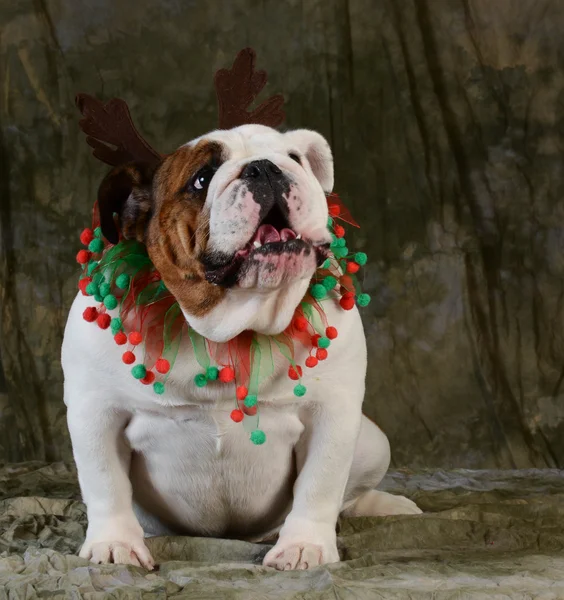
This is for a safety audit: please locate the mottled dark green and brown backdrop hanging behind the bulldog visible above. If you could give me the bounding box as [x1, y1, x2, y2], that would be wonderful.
[0, 0, 564, 467]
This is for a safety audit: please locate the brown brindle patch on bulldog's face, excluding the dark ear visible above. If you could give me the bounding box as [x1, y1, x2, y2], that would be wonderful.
[145, 141, 225, 317]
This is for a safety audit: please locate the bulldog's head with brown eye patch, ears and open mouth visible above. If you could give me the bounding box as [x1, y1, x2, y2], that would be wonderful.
[98, 125, 333, 341]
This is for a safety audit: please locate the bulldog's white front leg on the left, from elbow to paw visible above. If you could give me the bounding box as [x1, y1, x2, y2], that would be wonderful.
[65, 398, 154, 569]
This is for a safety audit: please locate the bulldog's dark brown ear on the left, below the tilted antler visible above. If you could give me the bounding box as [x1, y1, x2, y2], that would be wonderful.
[98, 162, 157, 244]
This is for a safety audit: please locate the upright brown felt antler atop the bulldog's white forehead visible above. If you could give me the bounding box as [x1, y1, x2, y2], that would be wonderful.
[214, 48, 285, 129]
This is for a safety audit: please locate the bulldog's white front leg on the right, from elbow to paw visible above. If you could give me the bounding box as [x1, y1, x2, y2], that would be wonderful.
[263, 400, 361, 570]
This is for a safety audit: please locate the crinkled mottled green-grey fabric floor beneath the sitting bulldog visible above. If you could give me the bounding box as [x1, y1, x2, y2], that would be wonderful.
[0, 463, 564, 600]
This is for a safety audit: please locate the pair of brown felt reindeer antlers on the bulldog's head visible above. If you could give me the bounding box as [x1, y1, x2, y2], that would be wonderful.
[76, 48, 285, 167]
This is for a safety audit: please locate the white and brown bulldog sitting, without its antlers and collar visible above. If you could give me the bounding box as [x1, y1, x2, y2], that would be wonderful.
[62, 125, 421, 570]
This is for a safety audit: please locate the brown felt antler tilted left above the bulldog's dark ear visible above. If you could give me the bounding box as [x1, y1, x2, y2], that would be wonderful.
[75, 94, 161, 166]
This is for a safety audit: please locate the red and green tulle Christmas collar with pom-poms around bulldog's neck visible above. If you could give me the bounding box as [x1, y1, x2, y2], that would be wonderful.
[76, 194, 370, 445]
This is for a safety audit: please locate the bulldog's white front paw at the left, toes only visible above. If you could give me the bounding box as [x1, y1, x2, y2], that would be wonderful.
[79, 531, 155, 571]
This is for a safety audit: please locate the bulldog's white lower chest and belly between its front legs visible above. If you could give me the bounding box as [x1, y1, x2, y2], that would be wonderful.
[126, 406, 303, 535]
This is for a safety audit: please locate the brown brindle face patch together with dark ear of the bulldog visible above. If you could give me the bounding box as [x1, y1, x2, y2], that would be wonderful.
[98, 141, 225, 317]
